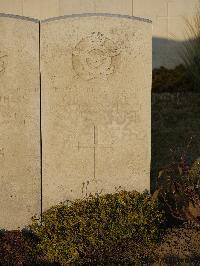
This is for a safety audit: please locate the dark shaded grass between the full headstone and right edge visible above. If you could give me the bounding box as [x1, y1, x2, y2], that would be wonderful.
[151, 93, 200, 190]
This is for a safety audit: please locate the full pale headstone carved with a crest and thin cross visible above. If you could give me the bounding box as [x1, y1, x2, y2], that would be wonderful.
[41, 15, 152, 209]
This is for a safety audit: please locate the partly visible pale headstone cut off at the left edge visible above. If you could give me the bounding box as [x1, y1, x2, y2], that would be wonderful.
[0, 14, 40, 229]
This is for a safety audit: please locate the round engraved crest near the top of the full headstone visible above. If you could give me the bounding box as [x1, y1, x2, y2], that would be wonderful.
[72, 32, 120, 80]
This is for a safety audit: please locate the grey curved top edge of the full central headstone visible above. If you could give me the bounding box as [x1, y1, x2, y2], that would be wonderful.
[41, 13, 152, 23]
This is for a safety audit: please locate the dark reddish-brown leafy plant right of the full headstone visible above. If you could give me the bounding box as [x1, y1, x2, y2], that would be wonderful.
[153, 139, 200, 226]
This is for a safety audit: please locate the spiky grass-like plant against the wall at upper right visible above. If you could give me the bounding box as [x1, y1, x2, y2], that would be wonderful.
[180, 2, 200, 90]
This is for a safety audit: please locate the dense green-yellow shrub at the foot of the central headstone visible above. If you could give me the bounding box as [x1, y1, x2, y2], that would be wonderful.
[30, 191, 164, 265]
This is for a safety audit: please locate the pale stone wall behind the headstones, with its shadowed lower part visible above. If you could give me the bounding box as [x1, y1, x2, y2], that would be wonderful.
[0, 0, 199, 68]
